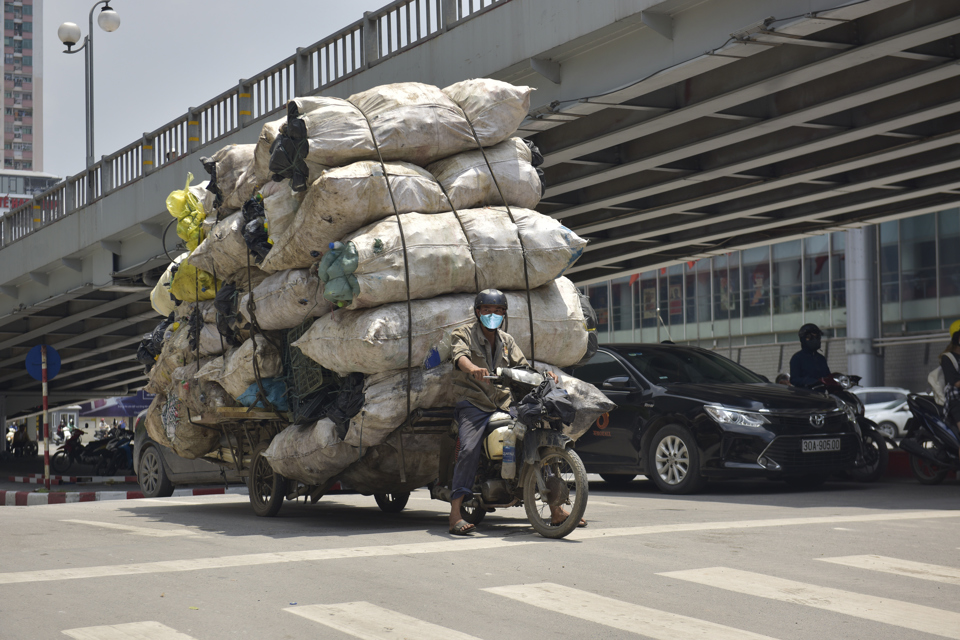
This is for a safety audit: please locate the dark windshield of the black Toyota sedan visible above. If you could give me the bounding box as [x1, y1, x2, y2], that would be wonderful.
[623, 347, 766, 384]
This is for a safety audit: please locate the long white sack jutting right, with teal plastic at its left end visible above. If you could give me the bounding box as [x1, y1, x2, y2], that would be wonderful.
[328, 208, 586, 309]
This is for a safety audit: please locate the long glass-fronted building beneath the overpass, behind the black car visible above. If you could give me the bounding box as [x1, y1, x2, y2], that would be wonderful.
[584, 209, 960, 376]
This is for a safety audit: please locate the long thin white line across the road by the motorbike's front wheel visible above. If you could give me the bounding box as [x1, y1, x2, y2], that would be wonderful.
[0, 511, 960, 584]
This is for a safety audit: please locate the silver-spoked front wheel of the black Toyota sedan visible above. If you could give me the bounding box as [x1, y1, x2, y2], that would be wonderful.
[647, 424, 707, 494]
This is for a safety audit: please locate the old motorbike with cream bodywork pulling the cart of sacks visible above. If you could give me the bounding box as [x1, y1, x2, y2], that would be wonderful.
[430, 368, 589, 538]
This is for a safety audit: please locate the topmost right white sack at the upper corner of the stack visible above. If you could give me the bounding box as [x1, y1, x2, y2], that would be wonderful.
[443, 78, 532, 147]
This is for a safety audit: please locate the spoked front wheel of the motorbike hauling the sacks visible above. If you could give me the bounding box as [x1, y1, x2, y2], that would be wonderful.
[523, 449, 590, 538]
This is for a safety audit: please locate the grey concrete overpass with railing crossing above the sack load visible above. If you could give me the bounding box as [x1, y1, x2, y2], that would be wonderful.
[0, 0, 960, 415]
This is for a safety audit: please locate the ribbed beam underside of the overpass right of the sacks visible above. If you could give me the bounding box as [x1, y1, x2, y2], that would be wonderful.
[525, 1, 960, 283]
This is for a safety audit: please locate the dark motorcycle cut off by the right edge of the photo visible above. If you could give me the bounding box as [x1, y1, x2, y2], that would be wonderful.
[900, 394, 960, 484]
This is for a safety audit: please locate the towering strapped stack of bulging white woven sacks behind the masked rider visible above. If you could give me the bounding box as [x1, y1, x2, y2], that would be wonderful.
[143, 79, 611, 492]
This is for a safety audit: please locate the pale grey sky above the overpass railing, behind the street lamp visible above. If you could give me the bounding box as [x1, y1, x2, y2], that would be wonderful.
[40, 0, 389, 177]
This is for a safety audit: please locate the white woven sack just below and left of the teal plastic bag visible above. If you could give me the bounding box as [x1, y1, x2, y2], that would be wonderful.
[237, 269, 334, 331]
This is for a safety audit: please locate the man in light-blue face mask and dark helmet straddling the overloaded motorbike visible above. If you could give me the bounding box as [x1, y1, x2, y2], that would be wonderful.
[450, 289, 586, 536]
